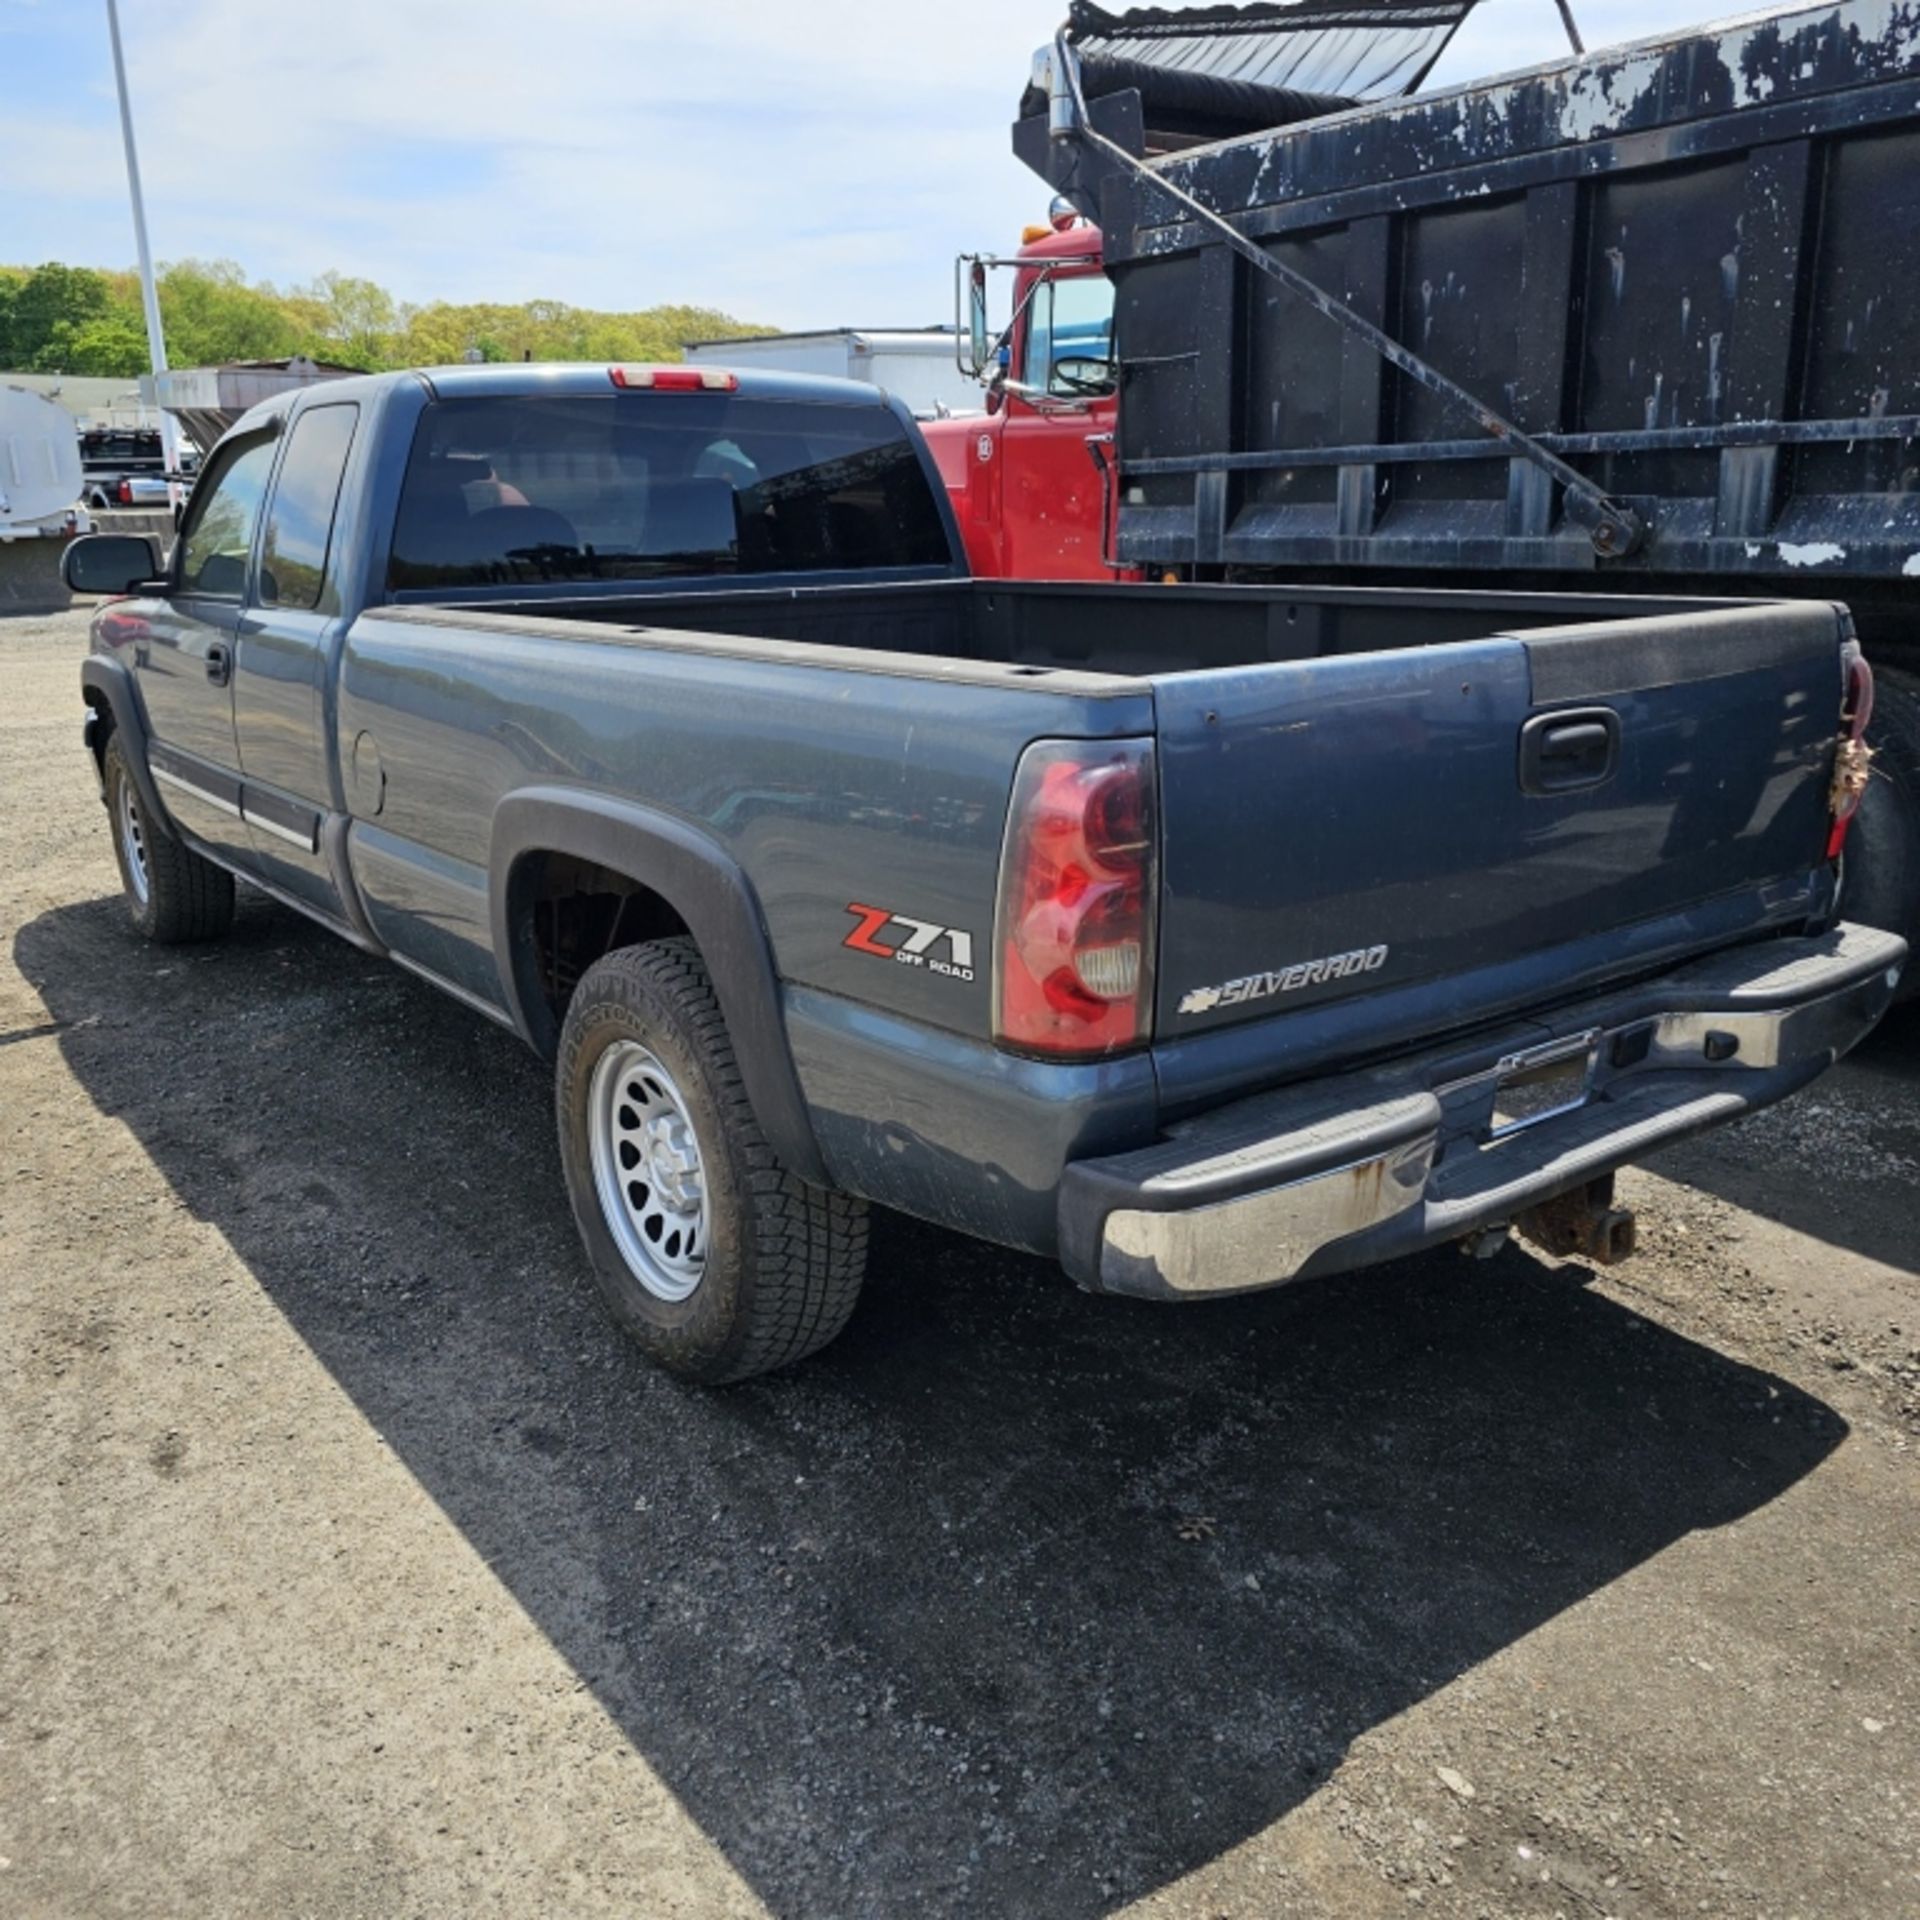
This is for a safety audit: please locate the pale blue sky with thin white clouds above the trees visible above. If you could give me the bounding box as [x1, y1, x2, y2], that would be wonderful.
[0, 0, 1740, 326]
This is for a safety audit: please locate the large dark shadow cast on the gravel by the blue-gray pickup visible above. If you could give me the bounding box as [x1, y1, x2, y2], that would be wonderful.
[15, 900, 1845, 1916]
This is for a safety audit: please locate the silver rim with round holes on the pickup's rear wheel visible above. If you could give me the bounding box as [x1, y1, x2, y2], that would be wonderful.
[588, 1041, 707, 1302]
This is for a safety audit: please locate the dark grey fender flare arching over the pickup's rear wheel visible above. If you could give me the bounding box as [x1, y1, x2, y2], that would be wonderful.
[488, 787, 833, 1187]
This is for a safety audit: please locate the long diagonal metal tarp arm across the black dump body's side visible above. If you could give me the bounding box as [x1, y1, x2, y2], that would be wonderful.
[1046, 23, 1647, 561]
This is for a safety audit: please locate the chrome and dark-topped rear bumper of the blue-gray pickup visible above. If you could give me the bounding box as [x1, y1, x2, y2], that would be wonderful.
[1060, 925, 1907, 1300]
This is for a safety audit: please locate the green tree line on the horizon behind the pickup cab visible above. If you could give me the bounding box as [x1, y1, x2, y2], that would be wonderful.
[0, 259, 764, 378]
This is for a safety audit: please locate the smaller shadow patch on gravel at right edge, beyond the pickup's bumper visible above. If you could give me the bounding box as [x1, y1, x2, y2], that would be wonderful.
[1647, 1002, 1920, 1273]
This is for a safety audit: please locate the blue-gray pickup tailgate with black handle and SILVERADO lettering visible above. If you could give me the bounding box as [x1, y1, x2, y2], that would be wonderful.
[1154, 603, 1847, 1041]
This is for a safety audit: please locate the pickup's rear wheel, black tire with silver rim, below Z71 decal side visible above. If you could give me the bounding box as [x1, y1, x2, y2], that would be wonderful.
[555, 939, 866, 1386]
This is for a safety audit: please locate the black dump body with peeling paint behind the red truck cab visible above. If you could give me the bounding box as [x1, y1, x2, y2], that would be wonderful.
[1016, 0, 1920, 648]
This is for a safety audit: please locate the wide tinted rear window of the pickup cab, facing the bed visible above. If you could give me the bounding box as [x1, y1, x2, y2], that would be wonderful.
[388, 394, 950, 588]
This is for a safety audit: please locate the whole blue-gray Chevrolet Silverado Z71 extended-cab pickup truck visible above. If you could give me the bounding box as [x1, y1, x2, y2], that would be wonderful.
[65, 367, 1905, 1380]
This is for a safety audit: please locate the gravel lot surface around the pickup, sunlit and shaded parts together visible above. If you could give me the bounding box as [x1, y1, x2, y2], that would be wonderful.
[0, 614, 1920, 1920]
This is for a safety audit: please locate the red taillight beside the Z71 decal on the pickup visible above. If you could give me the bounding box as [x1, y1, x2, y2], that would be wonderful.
[995, 739, 1156, 1054]
